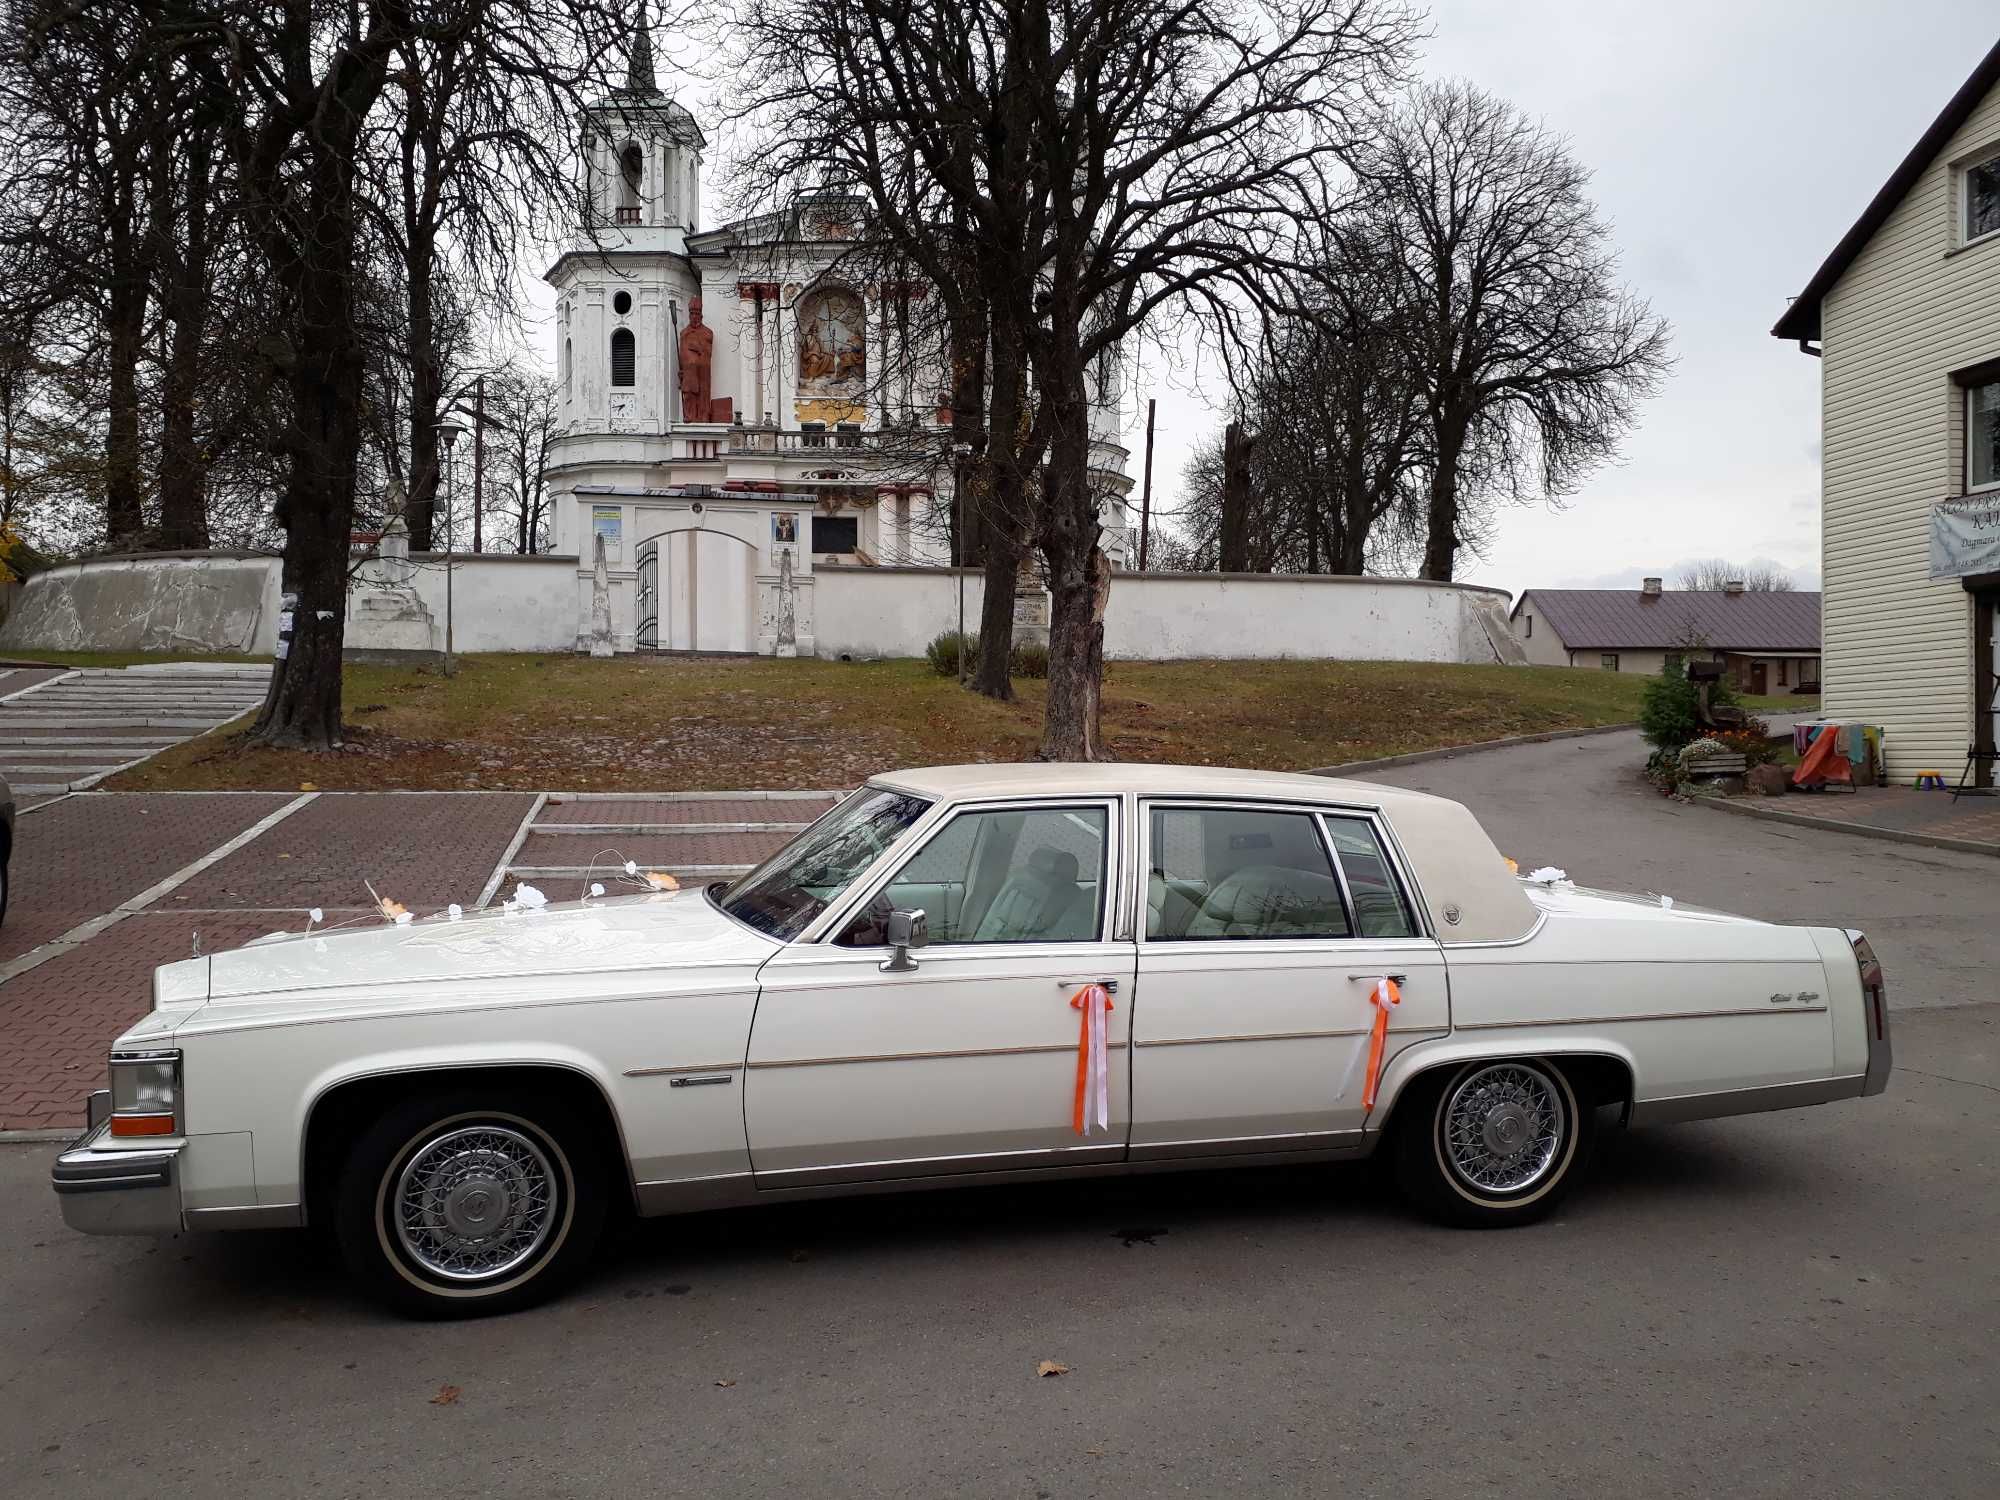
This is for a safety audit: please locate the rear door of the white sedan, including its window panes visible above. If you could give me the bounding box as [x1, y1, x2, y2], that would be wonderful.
[1132, 800, 1450, 1160]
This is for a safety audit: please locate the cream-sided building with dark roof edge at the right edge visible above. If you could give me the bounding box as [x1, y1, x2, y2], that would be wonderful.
[1772, 36, 2000, 782]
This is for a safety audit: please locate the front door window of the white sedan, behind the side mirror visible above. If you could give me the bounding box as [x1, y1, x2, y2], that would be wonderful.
[834, 804, 1108, 948]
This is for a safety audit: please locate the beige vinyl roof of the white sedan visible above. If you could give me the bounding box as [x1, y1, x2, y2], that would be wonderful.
[872, 762, 1538, 942]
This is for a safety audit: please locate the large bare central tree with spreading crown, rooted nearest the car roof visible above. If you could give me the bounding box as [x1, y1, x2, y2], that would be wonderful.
[736, 0, 1412, 760]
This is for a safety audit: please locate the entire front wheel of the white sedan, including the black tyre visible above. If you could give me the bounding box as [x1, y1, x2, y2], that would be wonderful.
[334, 1090, 606, 1318]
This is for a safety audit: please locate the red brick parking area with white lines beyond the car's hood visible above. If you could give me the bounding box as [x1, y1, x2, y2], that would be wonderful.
[0, 788, 804, 1130]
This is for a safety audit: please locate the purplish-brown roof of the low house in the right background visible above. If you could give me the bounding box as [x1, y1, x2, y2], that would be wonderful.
[1514, 588, 1820, 652]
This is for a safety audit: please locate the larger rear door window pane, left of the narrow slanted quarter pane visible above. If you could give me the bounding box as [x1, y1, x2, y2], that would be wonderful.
[1146, 808, 1354, 942]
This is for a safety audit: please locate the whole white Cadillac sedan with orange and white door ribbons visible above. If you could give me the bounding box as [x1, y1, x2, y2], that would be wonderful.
[54, 766, 1890, 1316]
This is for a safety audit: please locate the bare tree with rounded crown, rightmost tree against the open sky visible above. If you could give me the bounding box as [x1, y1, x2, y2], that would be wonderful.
[1362, 84, 1670, 578]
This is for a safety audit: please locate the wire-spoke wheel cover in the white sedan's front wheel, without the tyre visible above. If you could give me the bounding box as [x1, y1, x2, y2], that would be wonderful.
[386, 1124, 558, 1282]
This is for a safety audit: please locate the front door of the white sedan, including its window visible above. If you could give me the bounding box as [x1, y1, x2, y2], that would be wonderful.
[744, 798, 1134, 1188]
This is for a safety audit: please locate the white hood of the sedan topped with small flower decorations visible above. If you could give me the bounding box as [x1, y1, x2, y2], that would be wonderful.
[195, 890, 778, 1004]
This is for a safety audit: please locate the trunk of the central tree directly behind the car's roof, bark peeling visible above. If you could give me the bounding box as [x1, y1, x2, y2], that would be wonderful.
[1036, 360, 1110, 760]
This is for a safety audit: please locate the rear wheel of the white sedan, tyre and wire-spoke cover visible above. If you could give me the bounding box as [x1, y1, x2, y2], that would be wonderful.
[1396, 1058, 1596, 1228]
